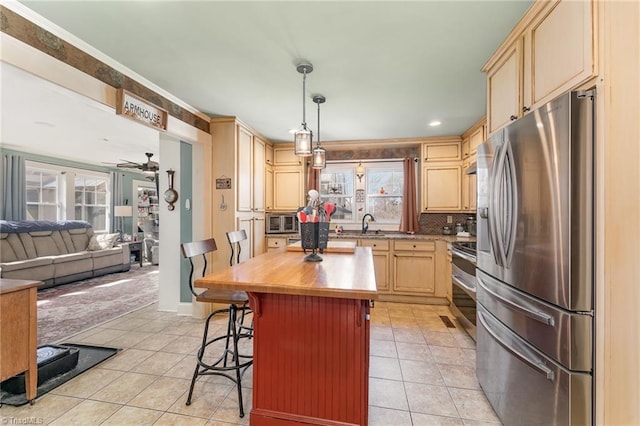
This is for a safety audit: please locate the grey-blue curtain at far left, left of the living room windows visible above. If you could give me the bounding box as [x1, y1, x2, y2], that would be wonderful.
[0, 154, 27, 220]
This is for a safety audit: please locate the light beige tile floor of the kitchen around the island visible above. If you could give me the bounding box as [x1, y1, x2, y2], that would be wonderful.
[0, 302, 500, 426]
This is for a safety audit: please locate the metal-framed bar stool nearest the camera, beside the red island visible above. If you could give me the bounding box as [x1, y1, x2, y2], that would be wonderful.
[181, 238, 253, 417]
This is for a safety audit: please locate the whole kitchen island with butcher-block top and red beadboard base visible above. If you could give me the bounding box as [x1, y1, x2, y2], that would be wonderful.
[195, 247, 377, 426]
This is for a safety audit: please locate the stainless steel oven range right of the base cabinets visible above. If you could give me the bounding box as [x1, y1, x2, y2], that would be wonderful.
[451, 242, 476, 340]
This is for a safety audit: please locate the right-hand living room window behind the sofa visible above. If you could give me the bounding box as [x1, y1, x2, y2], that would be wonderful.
[74, 174, 109, 232]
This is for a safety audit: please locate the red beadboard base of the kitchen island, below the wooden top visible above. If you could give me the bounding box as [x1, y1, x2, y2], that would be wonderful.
[249, 293, 370, 426]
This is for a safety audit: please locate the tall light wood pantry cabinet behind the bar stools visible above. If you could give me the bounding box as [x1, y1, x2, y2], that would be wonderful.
[211, 117, 267, 270]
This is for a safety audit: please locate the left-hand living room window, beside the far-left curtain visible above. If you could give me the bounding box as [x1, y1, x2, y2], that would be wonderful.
[26, 167, 60, 220]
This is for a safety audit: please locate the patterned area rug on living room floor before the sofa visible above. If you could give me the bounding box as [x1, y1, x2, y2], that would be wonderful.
[38, 265, 159, 346]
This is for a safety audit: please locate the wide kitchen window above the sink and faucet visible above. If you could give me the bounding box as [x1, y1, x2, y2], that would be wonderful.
[320, 161, 404, 225]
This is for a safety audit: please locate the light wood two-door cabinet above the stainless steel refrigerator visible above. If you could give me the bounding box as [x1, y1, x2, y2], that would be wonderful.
[483, 0, 597, 134]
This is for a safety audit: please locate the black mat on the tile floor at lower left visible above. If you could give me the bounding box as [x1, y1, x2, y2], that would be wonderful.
[0, 343, 120, 406]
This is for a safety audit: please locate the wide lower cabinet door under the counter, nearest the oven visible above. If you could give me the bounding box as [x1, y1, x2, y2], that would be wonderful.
[393, 251, 435, 294]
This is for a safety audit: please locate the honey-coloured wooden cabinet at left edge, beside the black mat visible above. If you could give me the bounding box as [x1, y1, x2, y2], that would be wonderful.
[0, 278, 42, 404]
